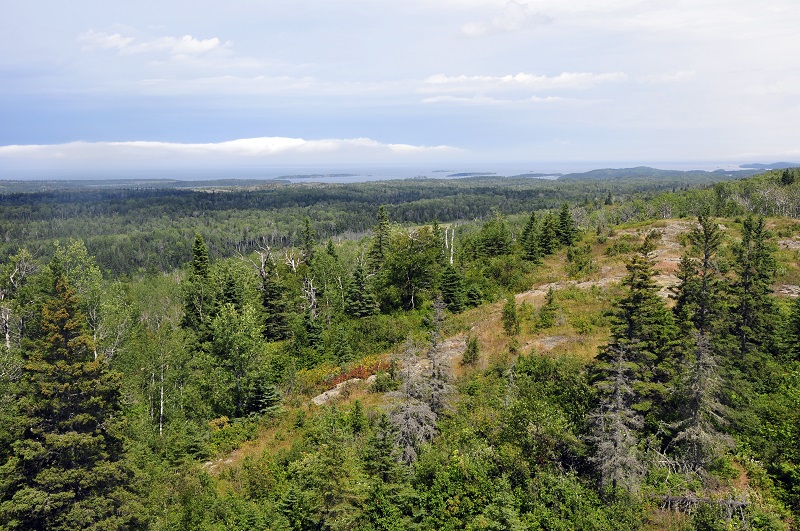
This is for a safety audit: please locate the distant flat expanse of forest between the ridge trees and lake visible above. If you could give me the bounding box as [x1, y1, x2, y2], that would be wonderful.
[0, 170, 764, 276]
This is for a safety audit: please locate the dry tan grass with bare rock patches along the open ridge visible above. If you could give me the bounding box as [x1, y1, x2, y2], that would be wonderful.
[206, 216, 800, 478]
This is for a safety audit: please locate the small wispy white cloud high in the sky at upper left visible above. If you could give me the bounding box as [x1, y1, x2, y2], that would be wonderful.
[78, 30, 230, 56]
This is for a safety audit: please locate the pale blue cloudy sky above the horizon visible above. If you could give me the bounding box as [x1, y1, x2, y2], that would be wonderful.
[0, 0, 800, 179]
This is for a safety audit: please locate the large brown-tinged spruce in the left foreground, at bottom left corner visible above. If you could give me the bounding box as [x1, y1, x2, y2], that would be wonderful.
[0, 274, 136, 530]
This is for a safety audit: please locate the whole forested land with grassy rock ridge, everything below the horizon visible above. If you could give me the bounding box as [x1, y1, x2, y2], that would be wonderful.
[0, 168, 800, 530]
